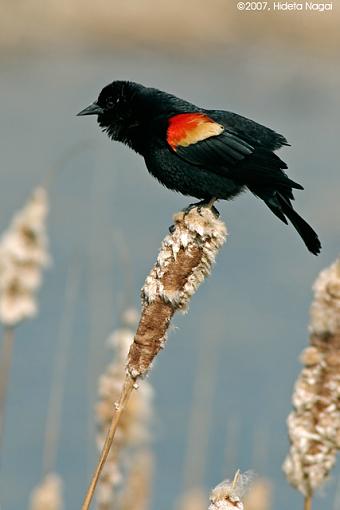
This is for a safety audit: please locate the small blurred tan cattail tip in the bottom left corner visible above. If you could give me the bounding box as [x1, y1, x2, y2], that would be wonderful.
[30, 473, 64, 510]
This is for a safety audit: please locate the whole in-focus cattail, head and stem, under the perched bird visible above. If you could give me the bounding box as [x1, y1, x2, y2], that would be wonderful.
[82, 208, 226, 510]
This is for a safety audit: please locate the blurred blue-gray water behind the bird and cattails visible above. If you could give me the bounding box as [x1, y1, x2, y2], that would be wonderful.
[0, 45, 340, 510]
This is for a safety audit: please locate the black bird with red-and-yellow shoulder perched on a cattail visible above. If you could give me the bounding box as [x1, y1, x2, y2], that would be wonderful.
[78, 81, 321, 255]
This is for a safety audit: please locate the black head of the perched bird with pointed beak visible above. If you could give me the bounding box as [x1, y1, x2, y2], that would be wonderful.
[78, 81, 144, 141]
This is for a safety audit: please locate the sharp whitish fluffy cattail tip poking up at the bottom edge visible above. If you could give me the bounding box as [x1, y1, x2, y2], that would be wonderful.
[209, 471, 254, 510]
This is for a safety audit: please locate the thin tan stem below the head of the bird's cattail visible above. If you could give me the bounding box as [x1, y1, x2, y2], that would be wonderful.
[82, 374, 136, 510]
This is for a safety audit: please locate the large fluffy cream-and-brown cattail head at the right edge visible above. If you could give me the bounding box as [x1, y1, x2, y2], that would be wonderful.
[283, 260, 340, 499]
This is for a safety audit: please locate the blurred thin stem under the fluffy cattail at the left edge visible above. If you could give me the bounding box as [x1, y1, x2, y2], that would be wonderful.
[0, 326, 14, 448]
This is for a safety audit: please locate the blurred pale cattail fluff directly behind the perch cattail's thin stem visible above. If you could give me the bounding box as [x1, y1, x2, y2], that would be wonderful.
[96, 311, 152, 510]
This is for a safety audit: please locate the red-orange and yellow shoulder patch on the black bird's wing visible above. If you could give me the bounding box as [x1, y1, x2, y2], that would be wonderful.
[166, 113, 224, 151]
